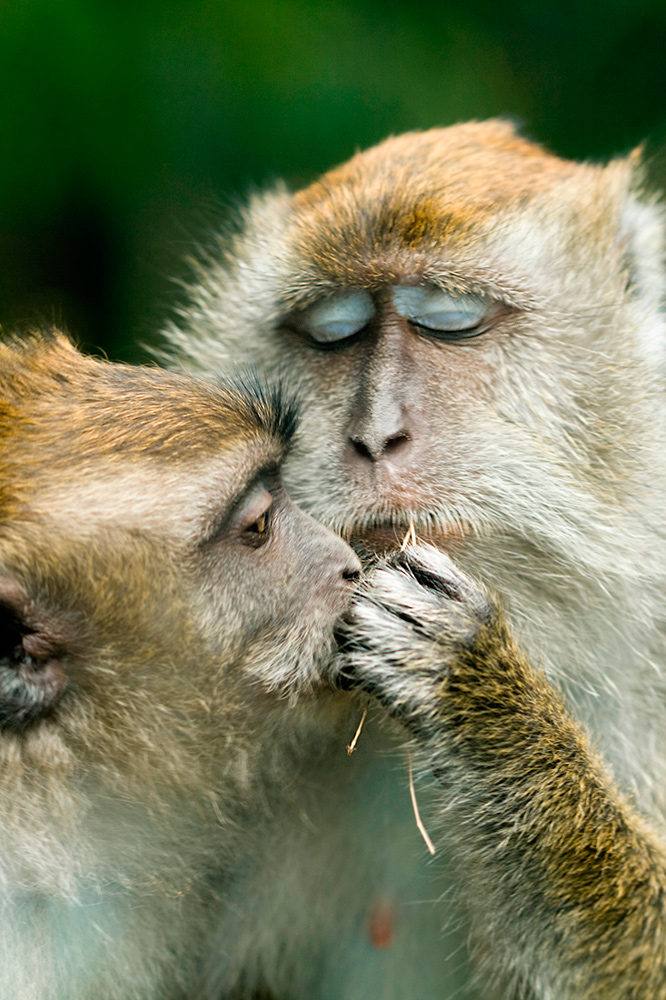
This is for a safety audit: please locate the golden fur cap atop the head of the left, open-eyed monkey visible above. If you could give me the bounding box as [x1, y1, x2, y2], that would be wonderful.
[0, 331, 293, 464]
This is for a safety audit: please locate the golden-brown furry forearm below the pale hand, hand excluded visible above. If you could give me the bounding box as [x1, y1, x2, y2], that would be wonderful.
[422, 636, 666, 1000]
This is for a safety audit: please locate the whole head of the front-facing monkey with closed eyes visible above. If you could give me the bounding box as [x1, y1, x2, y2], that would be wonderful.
[169, 121, 663, 584]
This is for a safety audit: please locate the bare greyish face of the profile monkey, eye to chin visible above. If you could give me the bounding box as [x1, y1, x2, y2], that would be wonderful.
[189, 468, 359, 696]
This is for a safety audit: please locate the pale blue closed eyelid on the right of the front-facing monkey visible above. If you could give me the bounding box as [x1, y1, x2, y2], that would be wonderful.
[393, 285, 490, 340]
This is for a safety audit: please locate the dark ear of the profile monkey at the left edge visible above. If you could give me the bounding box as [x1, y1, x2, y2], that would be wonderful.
[0, 576, 68, 729]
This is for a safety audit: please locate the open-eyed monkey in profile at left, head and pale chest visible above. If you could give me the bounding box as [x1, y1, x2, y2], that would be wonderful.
[0, 334, 366, 1000]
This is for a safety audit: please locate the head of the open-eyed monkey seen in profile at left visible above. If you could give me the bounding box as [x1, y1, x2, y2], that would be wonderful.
[0, 335, 357, 808]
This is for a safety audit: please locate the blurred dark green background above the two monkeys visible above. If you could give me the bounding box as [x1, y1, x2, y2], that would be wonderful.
[0, 0, 666, 359]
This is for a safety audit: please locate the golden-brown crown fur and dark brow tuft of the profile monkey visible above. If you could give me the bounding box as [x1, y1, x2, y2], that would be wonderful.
[0, 331, 296, 522]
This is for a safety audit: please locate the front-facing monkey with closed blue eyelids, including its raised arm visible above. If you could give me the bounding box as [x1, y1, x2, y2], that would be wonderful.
[167, 121, 666, 1000]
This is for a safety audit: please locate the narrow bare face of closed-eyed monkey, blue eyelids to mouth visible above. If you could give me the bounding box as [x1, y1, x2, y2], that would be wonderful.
[278, 282, 513, 549]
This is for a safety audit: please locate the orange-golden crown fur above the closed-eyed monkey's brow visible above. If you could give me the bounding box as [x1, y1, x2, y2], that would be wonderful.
[286, 121, 632, 288]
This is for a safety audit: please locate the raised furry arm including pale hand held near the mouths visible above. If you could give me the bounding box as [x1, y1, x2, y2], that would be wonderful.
[344, 547, 666, 1000]
